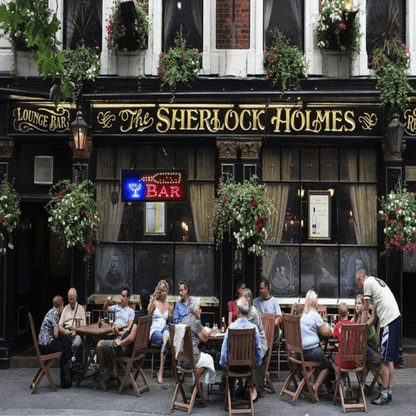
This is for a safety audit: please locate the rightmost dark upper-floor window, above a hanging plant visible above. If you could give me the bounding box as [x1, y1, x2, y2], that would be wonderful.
[366, 0, 406, 61]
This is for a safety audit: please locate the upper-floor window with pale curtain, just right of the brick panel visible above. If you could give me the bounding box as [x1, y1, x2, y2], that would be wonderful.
[263, 0, 304, 49]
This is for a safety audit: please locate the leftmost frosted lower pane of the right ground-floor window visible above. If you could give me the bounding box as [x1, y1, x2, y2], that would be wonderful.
[263, 247, 299, 297]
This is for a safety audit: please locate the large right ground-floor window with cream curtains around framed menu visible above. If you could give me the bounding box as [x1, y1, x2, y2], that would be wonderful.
[262, 146, 377, 298]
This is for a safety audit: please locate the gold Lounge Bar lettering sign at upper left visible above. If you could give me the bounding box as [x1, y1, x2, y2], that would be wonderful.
[12, 106, 70, 133]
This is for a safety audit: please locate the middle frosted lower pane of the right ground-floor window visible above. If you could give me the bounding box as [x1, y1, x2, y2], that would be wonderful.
[301, 247, 338, 298]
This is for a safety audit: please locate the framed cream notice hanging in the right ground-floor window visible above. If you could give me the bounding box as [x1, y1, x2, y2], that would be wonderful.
[308, 191, 331, 240]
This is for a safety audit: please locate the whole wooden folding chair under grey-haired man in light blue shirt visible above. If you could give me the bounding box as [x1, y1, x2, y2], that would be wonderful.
[224, 328, 255, 416]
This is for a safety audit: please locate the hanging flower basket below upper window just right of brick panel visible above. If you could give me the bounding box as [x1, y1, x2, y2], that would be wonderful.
[264, 30, 308, 94]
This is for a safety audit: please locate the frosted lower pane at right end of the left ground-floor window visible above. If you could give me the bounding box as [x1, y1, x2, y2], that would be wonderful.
[175, 245, 214, 296]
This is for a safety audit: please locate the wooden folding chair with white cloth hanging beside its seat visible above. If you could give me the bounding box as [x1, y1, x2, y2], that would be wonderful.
[169, 324, 207, 414]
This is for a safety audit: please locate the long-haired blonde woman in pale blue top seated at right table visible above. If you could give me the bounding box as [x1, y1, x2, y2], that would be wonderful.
[300, 290, 334, 396]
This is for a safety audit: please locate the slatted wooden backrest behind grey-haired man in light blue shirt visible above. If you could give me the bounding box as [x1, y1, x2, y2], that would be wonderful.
[227, 328, 256, 368]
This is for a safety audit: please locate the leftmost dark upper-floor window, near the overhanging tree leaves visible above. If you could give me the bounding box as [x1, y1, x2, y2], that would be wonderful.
[64, 0, 103, 49]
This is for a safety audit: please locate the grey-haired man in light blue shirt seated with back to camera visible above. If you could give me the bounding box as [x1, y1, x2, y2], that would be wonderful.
[220, 297, 262, 400]
